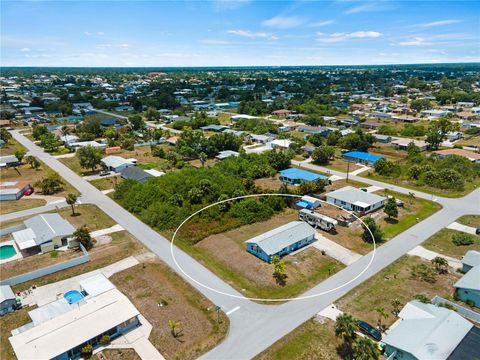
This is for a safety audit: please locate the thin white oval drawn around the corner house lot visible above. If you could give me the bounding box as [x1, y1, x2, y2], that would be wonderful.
[170, 194, 377, 302]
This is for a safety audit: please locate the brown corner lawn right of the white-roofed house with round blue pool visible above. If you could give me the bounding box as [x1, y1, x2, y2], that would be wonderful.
[111, 261, 229, 359]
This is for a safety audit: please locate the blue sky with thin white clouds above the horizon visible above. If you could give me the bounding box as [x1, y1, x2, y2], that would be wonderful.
[0, 0, 480, 66]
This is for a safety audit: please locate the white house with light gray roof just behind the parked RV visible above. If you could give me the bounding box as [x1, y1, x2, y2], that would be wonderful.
[327, 186, 387, 214]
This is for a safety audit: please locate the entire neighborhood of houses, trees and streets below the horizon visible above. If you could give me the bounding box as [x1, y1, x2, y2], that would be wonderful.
[0, 64, 480, 360]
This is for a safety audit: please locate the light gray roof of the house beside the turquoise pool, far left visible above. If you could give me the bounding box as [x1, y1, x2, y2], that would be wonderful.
[24, 214, 75, 245]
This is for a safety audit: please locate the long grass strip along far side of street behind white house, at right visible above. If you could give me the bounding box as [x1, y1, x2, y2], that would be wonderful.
[358, 171, 480, 198]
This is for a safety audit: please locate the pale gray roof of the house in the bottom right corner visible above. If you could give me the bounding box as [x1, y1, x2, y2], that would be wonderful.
[382, 300, 473, 360]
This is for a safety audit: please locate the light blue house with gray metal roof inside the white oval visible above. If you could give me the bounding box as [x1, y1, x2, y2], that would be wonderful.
[245, 221, 315, 262]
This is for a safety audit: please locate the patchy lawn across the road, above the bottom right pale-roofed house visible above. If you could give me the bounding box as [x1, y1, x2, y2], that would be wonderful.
[336, 255, 460, 326]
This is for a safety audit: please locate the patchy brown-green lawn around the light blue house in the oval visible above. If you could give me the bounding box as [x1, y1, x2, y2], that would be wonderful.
[172, 209, 343, 298]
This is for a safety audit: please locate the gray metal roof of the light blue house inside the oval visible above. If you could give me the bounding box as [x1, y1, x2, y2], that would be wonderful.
[245, 221, 315, 255]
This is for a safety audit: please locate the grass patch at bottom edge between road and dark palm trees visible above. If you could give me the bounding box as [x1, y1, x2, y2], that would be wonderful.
[254, 320, 342, 360]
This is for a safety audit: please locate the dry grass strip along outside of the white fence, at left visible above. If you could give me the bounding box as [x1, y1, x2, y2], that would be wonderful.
[10, 231, 145, 292]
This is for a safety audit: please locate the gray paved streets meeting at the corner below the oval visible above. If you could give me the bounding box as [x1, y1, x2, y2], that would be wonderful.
[8, 131, 480, 359]
